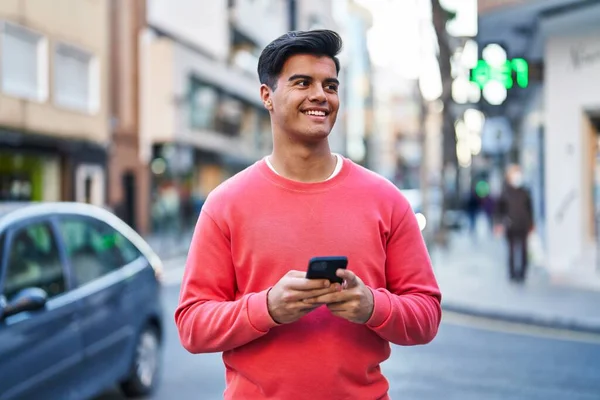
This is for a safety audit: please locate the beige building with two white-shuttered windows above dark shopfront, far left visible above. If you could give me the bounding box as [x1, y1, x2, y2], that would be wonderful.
[0, 0, 110, 205]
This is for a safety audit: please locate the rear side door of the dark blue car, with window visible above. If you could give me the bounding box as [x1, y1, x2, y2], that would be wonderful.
[56, 215, 136, 383]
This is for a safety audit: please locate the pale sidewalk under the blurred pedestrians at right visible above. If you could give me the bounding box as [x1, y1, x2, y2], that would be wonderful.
[431, 222, 600, 333]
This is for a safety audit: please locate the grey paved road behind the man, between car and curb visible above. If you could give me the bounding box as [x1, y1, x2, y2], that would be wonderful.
[96, 258, 600, 400]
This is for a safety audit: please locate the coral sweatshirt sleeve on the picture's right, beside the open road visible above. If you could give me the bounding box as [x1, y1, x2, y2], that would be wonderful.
[367, 206, 442, 346]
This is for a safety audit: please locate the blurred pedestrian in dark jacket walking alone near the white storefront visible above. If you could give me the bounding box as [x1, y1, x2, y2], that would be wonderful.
[496, 164, 534, 282]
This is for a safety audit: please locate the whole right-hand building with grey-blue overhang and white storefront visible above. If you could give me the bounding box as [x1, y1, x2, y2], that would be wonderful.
[478, 0, 600, 283]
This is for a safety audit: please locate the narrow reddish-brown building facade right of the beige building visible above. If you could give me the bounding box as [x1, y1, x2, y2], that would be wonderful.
[108, 0, 150, 234]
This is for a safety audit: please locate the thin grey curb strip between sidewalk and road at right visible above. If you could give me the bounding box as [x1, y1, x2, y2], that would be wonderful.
[442, 300, 600, 334]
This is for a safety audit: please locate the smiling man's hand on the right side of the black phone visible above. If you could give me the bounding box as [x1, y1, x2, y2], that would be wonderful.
[305, 269, 374, 324]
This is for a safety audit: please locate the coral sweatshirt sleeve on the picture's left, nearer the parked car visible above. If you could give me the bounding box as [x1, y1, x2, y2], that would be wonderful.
[175, 210, 277, 353]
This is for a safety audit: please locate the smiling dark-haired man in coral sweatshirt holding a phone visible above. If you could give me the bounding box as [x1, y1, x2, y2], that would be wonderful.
[175, 30, 441, 400]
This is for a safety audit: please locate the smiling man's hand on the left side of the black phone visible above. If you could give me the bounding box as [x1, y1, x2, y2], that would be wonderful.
[267, 271, 341, 324]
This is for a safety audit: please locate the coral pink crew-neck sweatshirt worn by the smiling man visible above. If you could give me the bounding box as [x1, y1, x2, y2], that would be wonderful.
[175, 159, 441, 400]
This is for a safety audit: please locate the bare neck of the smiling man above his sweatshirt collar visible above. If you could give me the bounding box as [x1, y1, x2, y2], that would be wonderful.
[269, 140, 337, 183]
